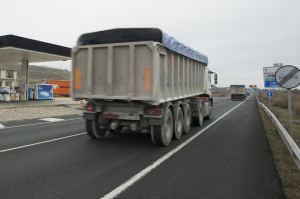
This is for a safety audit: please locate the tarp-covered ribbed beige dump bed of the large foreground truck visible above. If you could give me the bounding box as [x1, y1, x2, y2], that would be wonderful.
[72, 29, 208, 104]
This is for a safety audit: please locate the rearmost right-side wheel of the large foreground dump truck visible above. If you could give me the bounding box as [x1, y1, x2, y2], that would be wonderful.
[151, 109, 174, 146]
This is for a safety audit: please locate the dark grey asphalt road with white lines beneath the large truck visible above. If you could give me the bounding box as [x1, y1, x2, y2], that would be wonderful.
[0, 97, 284, 199]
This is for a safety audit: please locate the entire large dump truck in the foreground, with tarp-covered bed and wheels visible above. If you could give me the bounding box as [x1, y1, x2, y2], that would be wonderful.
[72, 28, 218, 146]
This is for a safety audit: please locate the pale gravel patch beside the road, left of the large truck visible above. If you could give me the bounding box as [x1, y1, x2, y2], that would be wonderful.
[0, 105, 82, 122]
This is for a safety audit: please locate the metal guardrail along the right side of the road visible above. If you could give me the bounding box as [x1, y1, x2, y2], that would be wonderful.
[256, 97, 300, 170]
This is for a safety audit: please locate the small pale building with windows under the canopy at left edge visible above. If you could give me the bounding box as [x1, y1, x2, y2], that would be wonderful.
[0, 66, 17, 89]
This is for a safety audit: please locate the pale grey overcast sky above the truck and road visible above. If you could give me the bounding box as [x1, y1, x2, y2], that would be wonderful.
[0, 0, 300, 86]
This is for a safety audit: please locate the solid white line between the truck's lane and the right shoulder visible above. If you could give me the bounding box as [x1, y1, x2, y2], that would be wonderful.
[101, 100, 246, 199]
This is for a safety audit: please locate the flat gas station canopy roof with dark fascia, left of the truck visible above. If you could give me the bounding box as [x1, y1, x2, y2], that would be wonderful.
[0, 35, 71, 64]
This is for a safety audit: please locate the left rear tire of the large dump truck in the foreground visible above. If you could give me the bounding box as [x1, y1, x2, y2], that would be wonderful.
[85, 114, 108, 139]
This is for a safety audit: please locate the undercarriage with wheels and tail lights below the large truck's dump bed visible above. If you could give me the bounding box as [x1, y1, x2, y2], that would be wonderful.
[83, 97, 213, 146]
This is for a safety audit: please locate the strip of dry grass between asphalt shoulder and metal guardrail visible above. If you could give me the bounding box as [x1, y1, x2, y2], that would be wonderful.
[259, 108, 300, 199]
